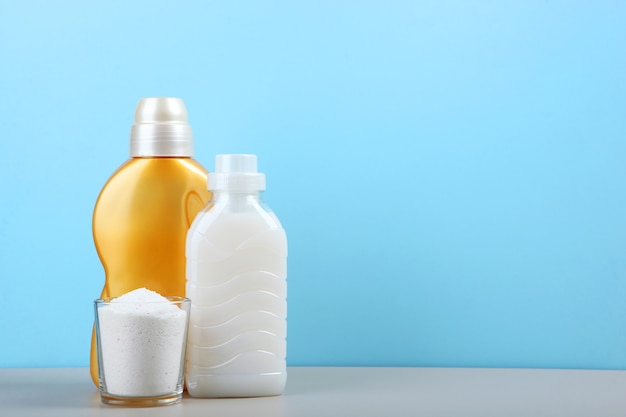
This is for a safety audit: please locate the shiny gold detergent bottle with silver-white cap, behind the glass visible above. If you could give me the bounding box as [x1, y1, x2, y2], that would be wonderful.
[91, 98, 211, 385]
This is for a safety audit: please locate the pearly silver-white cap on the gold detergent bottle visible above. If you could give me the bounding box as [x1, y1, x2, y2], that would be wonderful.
[130, 97, 193, 157]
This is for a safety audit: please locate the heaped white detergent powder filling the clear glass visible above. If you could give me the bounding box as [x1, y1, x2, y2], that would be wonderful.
[98, 288, 187, 397]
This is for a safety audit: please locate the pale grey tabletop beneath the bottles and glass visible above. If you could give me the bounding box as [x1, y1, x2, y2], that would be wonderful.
[0, 367, 626, 417]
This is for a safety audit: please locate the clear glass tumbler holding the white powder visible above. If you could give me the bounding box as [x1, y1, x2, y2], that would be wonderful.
[94, 297, 191, 407]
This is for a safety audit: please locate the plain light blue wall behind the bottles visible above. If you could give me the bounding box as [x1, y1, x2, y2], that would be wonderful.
[0, 0, 626, 369]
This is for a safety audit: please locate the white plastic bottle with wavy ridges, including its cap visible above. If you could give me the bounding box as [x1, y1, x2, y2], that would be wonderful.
[186, 155, 287, 398]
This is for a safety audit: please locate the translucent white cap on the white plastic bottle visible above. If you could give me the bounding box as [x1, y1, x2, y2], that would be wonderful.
[207, 154, 265, 192]
